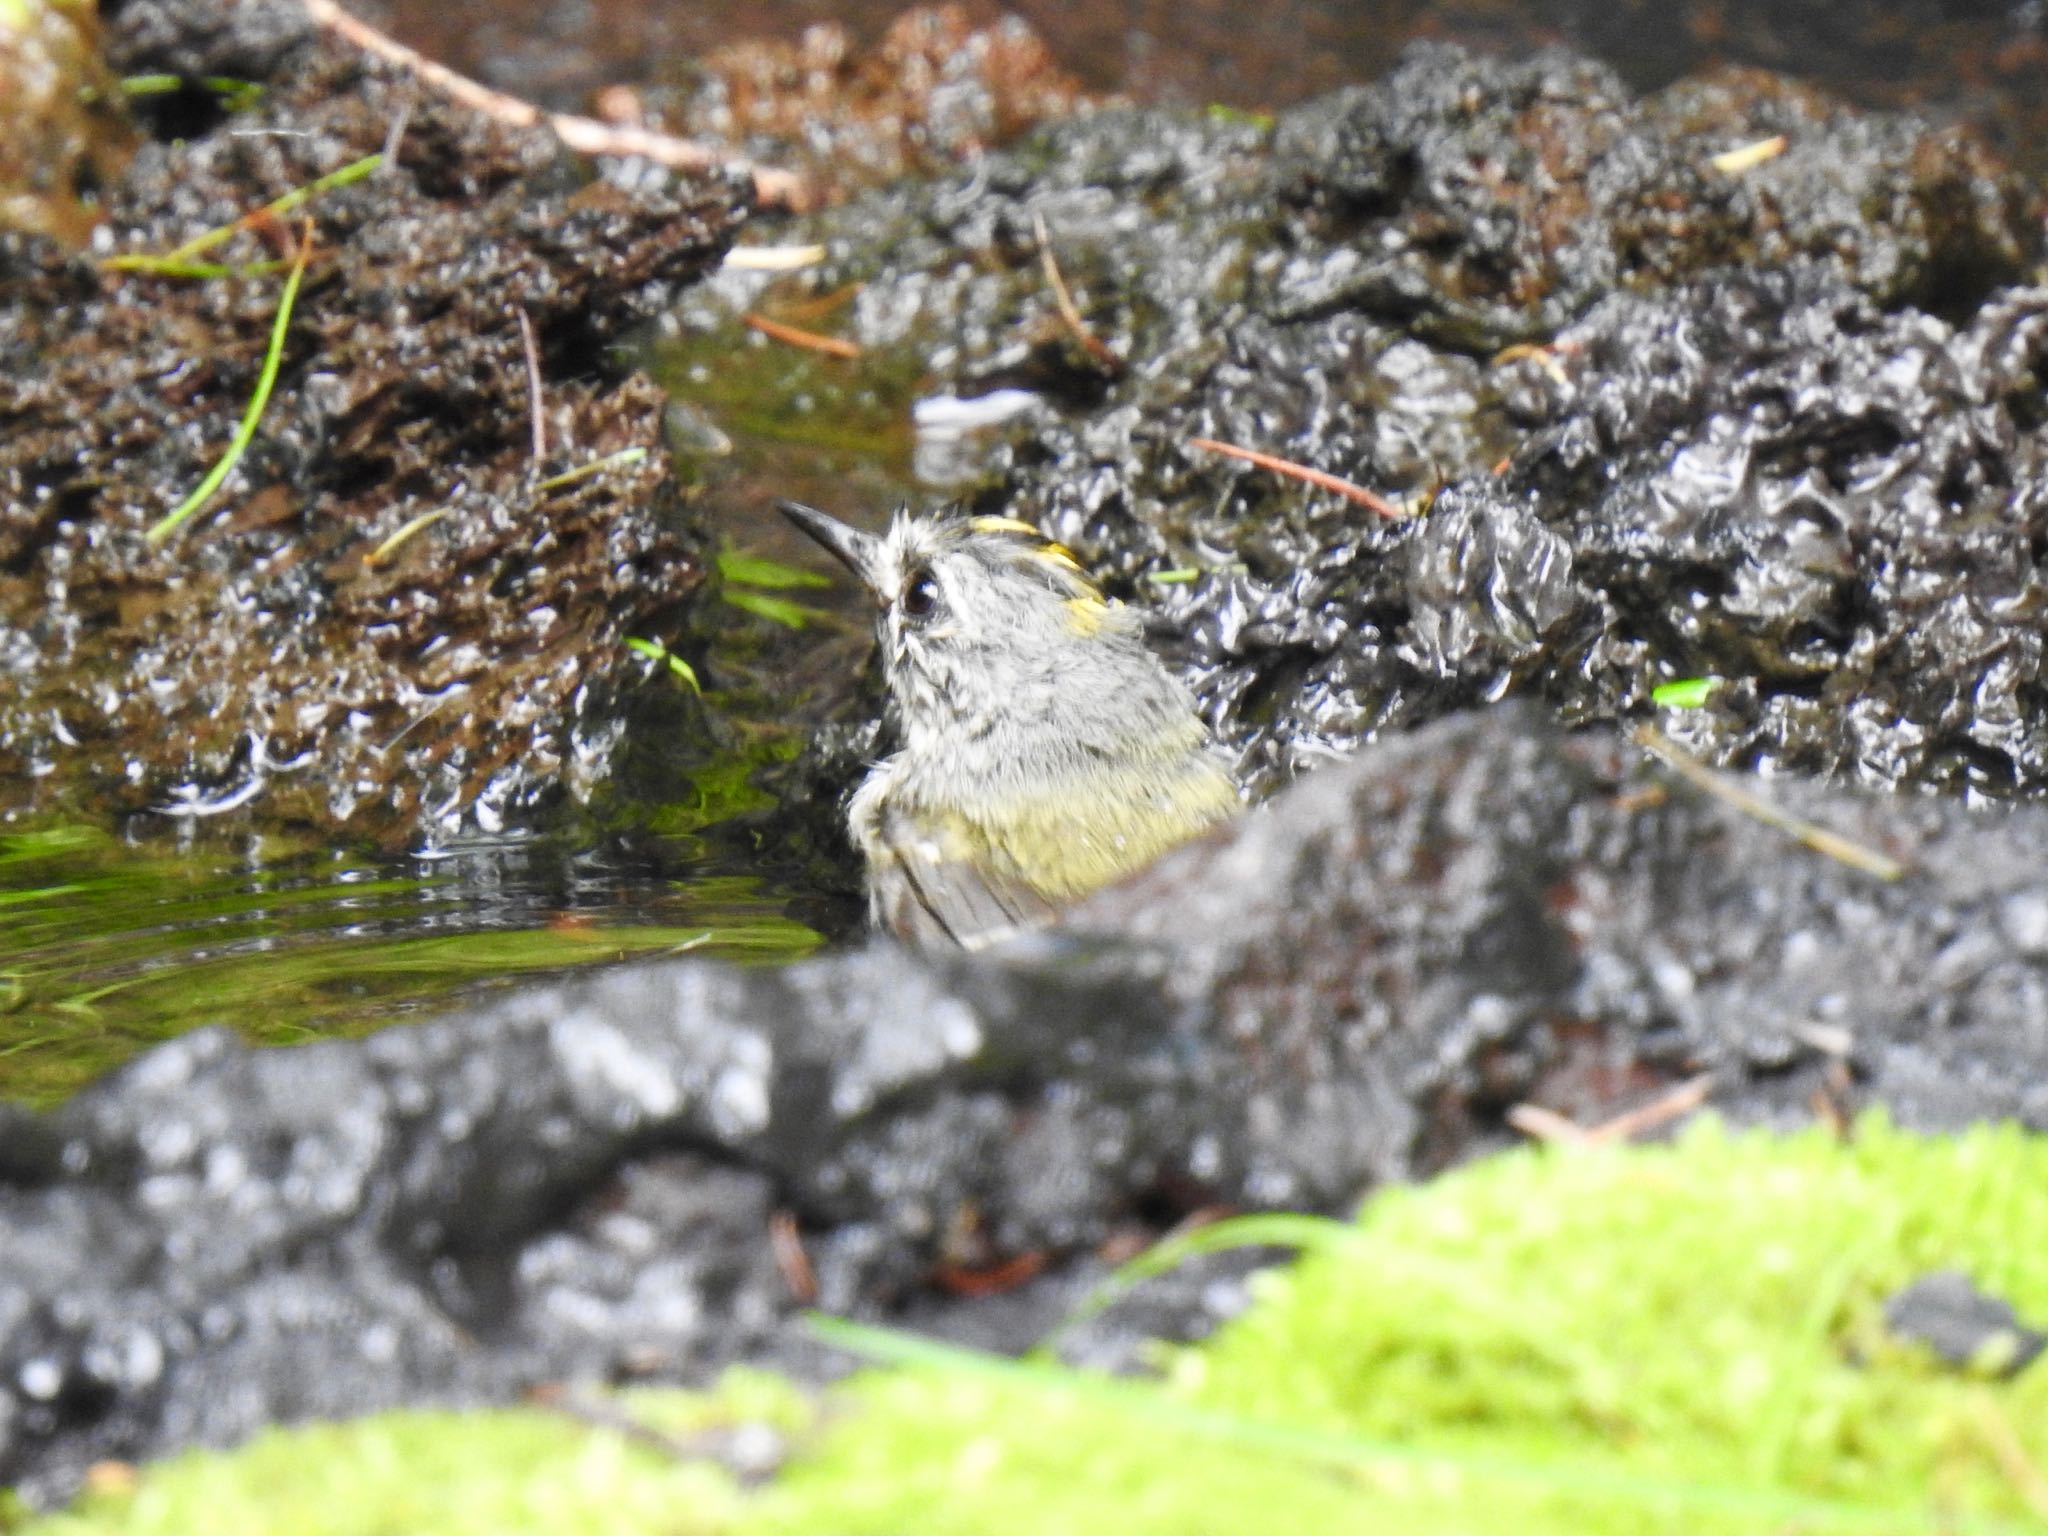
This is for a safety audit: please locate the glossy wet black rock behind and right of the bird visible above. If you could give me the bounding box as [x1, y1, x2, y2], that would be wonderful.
[724, 45, 2048, 819]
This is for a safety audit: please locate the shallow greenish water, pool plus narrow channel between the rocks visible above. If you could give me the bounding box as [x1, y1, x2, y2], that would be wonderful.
[0, 274, 1007, 1104]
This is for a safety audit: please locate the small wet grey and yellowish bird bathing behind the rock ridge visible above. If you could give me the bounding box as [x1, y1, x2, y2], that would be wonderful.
[776, 502, 1239, 948]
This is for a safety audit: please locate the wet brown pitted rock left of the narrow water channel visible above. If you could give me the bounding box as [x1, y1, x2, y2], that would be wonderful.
[0, 0, 748, 840]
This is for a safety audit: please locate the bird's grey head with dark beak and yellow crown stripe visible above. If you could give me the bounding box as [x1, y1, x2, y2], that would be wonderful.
[778, 502, 1159, 745]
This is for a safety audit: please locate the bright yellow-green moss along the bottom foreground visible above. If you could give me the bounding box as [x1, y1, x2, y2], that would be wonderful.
[19, 1120, 2048, 1536]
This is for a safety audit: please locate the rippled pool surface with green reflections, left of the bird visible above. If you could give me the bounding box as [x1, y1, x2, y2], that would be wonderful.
[0, 827, 817, 1102]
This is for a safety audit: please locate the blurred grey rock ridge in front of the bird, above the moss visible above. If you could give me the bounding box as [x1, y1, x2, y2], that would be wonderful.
[0, 709, 2048, 1497]
